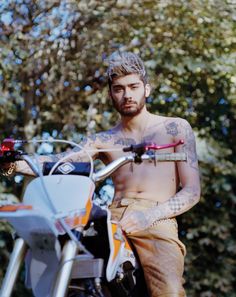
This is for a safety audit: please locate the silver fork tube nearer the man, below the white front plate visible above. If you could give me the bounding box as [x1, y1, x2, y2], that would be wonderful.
[51, 240, 78, 297]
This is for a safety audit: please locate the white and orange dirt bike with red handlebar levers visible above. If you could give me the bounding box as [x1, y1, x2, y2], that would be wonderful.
[0, 139, 186, 297]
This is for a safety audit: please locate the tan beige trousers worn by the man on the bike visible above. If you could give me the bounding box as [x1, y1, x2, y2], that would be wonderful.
[110, 198, 186, 297]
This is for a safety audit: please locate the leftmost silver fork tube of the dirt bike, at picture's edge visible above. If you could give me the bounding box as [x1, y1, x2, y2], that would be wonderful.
[0, 238, 26, 297]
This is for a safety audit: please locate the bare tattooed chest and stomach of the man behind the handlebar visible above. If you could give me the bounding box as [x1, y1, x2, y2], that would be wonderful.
[89, 116, 181, 202]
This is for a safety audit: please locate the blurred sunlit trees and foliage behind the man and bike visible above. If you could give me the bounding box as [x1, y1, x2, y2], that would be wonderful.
[0, 0, 236, 297]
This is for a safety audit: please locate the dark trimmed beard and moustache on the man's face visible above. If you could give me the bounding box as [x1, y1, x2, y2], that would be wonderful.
[111, 96, 146, 117]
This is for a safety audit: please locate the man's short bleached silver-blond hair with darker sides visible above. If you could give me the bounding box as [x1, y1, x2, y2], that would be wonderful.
[107, 51, 147, 86]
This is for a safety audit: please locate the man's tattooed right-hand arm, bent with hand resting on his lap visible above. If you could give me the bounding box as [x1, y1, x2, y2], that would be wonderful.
[121, 119, 200, 233]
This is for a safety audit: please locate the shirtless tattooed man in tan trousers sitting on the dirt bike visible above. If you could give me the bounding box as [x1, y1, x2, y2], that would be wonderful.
[5, 52, 200, 297]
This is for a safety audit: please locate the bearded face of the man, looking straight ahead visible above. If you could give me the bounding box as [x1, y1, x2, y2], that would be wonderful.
[110, 74, 150, 116]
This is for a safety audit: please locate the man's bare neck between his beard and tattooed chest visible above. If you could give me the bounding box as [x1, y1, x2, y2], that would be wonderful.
[121, 107, 151, 131]
